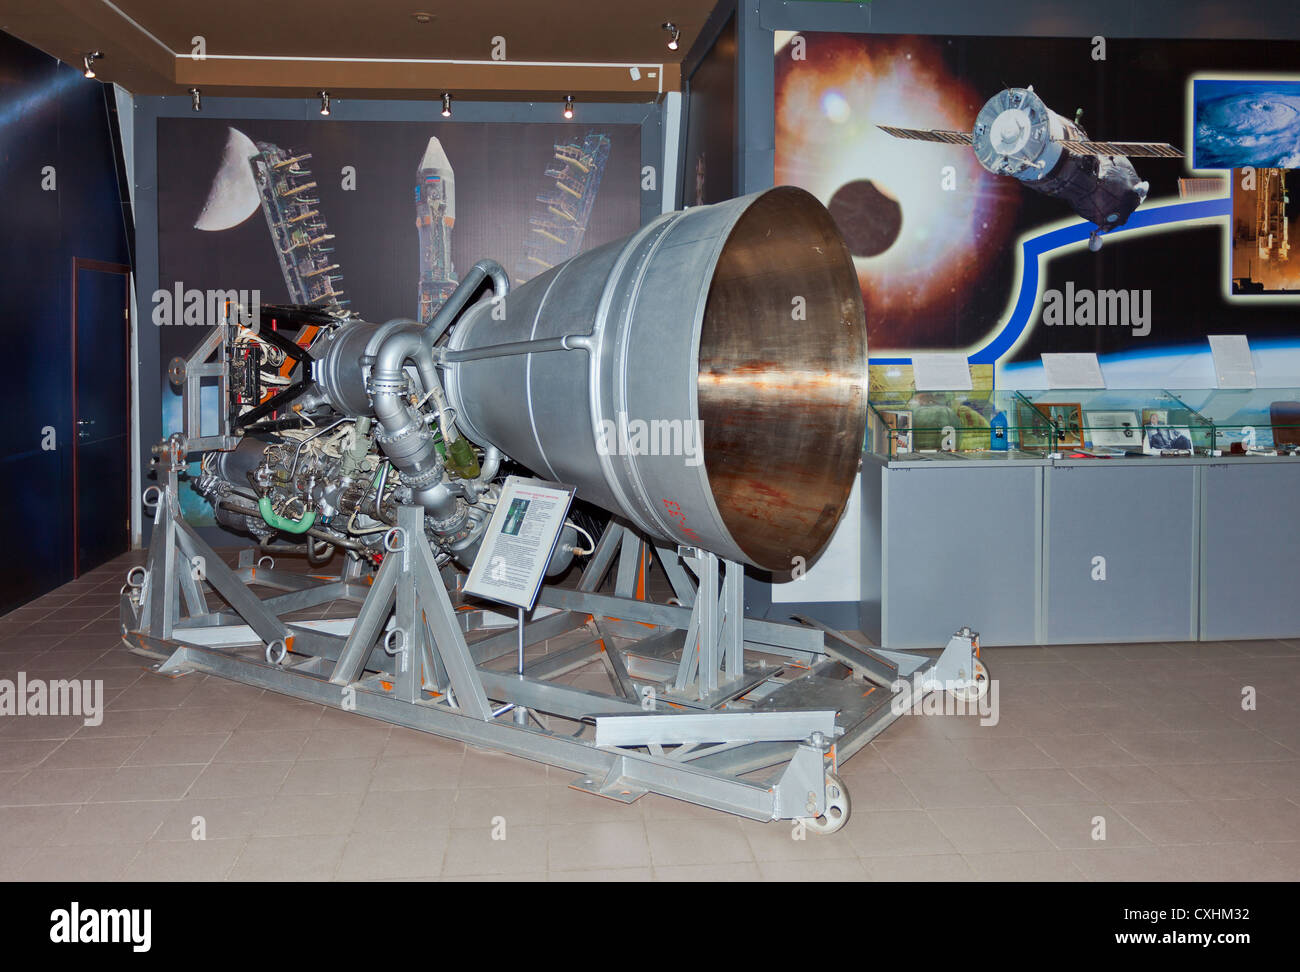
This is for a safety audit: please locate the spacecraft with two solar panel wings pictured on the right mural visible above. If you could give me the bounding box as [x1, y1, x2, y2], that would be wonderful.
[878, 84, 1183, 251]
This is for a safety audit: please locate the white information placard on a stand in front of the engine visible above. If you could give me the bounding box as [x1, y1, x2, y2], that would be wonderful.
[464, 476, 575, 611]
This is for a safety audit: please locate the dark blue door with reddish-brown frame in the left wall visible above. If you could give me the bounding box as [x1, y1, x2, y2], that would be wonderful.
[72, 257, 131, 577]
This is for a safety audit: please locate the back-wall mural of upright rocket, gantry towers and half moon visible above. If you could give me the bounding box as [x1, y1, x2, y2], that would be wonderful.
[159, 118, 641, 522]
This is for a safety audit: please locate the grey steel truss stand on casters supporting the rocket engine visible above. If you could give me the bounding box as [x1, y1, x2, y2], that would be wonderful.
[121, 475, 987, 833]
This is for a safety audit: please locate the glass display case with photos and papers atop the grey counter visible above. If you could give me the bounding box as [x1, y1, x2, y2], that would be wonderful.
[865, 389, 1300, 461]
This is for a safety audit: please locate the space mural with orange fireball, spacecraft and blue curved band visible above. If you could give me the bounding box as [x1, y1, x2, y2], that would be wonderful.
[775, 31, 1300, 387]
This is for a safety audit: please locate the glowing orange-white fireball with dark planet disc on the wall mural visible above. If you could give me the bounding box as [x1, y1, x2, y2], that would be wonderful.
[774, 34, 1021, 353]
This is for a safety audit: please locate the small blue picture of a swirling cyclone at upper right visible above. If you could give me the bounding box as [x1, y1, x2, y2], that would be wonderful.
[1192, 81, 1300, 169]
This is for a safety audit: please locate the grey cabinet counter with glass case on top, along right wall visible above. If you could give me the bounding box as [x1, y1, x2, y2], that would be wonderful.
[746, 390, 1300, 648]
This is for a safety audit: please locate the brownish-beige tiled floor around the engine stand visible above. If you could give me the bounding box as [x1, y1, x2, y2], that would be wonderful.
[0, 555, 1300, 881]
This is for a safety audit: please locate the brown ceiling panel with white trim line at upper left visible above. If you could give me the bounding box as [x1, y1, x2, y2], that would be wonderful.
[0, 0, 718, 101]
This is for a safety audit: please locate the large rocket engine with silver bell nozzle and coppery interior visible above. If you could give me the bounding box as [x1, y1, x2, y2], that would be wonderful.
[170, 187, 867, 573]
